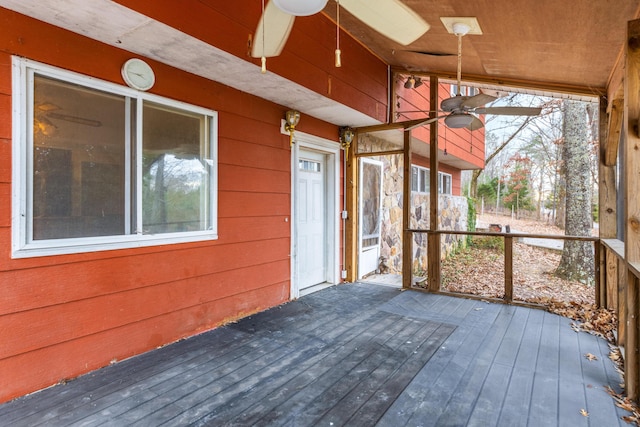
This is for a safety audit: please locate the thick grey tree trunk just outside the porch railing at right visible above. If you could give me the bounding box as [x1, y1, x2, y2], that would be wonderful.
[555, 101, 595, 284]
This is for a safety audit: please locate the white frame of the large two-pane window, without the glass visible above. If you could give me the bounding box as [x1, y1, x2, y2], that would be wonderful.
[11, 56, 218, 258]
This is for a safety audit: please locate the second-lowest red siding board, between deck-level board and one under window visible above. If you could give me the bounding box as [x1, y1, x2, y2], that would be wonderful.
[0, 260, 289, 359]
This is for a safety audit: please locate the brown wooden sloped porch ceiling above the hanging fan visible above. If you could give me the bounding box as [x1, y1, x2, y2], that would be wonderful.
[324, 0, 640, 95]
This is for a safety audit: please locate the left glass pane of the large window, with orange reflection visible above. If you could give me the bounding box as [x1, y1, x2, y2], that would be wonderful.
[31, 76, 125, 240]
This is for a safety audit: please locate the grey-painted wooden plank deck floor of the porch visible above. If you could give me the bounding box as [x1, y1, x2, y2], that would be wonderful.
[0, 283, 627, 427]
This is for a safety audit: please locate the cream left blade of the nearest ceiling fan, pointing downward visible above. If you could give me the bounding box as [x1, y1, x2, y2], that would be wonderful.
[251, 1, 295, 58]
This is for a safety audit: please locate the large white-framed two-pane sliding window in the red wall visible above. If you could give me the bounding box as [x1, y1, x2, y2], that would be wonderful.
[13, 58, 217, 257]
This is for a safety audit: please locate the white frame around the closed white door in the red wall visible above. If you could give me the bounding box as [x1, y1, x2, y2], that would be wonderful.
[287, 131, 341, 299]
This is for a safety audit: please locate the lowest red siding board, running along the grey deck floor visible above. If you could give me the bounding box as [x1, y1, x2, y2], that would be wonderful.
[0, 282, 289, 400]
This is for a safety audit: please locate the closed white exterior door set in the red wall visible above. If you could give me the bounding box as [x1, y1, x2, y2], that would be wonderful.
[296, 150, 327, 290]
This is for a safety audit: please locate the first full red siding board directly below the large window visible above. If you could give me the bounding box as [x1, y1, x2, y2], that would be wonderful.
[0, 239, 290, 315]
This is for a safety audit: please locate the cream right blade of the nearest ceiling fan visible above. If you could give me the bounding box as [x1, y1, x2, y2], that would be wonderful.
[340, 0, 430, 46]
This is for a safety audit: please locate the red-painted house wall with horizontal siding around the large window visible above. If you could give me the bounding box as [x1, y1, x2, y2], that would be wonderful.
[0, 4, 386, 402]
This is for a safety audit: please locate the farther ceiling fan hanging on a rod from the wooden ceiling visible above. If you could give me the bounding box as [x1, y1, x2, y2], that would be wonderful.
[405, 23, 542, 131]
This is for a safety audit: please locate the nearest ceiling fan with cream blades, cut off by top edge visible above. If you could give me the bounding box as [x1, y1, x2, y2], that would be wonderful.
[251, 0, 430, 58]
